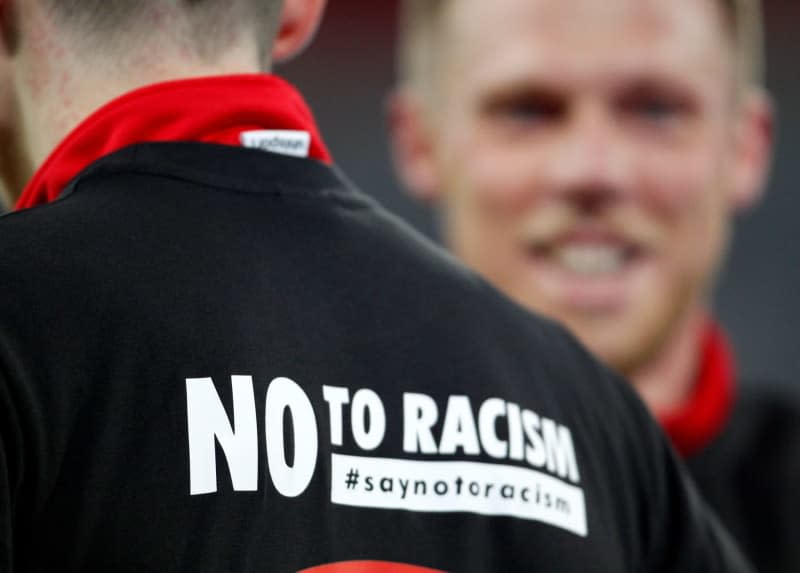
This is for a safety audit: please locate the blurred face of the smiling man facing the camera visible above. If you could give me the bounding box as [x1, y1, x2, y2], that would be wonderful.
[416, 0, 760, 373]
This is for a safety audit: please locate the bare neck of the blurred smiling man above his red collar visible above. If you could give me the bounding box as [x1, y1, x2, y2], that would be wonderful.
[630, 307, 707, 414]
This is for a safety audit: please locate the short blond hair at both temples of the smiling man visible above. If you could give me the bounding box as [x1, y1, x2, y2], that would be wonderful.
[398, 0, 765, 92]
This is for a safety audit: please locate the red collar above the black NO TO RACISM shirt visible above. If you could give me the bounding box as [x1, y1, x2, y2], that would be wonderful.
[16, 74, 331, 209]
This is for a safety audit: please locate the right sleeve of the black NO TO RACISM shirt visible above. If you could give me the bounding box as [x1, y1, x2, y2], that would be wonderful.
[554, 330, 755, 573]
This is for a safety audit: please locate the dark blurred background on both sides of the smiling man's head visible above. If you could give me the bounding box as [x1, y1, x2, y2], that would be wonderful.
[278, 0, 800, 394]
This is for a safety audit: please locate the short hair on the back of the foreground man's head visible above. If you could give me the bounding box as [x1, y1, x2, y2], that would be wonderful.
[43, 0, 283, 66]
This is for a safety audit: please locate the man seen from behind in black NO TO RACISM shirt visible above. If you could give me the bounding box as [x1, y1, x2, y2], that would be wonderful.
[0, 0, 760, 573]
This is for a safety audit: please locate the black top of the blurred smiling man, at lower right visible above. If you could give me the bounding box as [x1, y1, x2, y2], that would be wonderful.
[687, 383, 800, 573]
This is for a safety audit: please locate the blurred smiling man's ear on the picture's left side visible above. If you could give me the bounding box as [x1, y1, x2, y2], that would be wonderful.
[387, 90, 442, 202]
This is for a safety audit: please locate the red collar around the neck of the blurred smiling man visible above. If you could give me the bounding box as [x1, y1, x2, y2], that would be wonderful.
[659, 323, 735, 457]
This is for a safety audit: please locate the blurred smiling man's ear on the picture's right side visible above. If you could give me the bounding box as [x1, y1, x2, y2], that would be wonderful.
[731, 89, 775, 211]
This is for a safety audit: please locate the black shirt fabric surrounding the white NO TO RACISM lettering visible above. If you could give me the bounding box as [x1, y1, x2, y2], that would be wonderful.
[0, 143, 749, 573]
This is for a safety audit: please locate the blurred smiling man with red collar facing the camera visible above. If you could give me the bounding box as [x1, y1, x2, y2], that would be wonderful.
[392, 0, 800, 572]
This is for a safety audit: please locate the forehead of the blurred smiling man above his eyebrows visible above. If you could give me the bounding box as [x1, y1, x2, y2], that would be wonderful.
[442, 0, 730, 87]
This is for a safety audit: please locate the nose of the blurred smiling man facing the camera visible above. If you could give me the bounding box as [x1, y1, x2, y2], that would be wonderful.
[550, 104, 634, 210]
